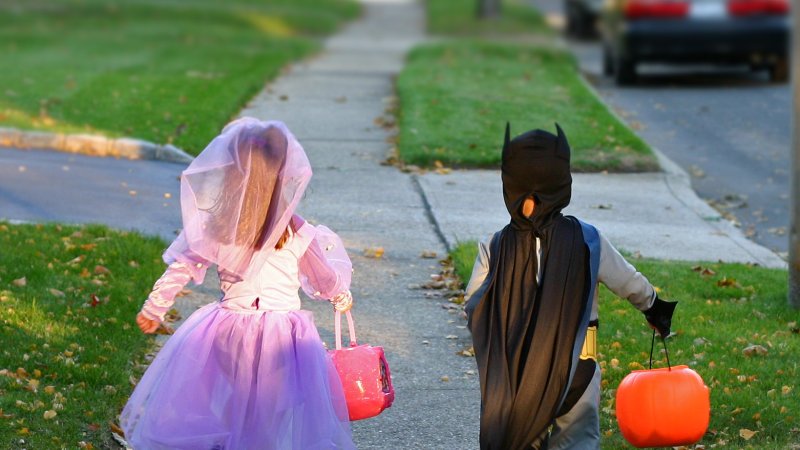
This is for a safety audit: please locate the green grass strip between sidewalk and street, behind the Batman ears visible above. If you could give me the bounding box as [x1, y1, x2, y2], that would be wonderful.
[397, 0, 658, 172]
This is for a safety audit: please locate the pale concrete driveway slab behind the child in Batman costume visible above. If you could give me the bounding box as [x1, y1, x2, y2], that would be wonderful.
[420, 156, 787, 268]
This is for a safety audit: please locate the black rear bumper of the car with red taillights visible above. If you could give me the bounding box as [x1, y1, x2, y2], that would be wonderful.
[621, 17, 790, 63]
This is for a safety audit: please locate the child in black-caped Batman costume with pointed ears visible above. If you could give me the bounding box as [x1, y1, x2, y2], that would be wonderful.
[466, 125, 676, 450]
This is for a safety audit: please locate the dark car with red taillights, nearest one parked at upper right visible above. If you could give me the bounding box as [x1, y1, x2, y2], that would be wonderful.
[599, 0, 791, 84]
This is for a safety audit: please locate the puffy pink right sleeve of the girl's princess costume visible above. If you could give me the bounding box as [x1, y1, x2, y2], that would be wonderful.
[300, 225, 353, 300]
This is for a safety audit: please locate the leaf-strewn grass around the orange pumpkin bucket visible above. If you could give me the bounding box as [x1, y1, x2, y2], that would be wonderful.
[452, 242, 800, 449]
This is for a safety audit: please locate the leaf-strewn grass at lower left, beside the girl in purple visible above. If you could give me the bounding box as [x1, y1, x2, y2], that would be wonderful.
[0, 222, 165, 449]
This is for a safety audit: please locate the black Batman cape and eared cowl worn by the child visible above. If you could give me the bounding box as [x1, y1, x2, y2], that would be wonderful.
[469, 125, 592, 450]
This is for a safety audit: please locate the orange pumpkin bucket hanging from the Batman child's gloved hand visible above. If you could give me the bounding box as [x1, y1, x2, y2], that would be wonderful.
[616, 334, 711, 448]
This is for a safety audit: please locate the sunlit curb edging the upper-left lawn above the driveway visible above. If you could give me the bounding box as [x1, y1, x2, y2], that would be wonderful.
[0, 127, 194, 164]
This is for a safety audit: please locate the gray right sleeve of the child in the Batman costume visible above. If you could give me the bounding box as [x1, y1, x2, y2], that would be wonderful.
[597, 232, 656, 311]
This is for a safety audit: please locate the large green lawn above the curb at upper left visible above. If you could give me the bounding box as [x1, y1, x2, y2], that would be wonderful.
[0, 0, 359, 154]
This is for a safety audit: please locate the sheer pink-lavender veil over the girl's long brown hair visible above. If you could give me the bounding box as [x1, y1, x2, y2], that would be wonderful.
[164, 117, 311, 280]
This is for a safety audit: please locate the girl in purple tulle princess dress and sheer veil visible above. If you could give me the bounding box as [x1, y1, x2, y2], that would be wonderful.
[121, 118, 355, 450]
